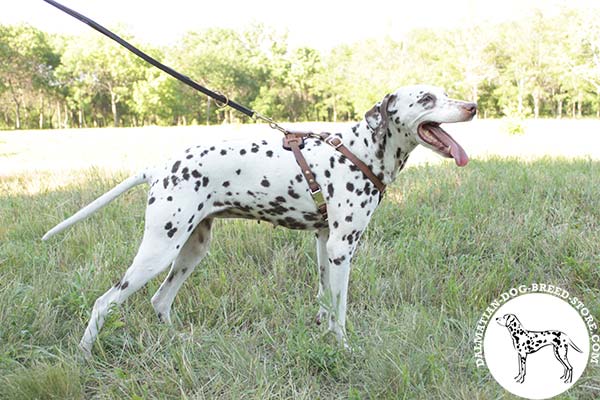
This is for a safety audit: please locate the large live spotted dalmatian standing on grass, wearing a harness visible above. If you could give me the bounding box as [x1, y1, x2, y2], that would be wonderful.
[43, 85, 477, 356]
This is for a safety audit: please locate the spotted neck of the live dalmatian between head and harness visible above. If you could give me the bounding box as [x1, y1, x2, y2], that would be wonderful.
[342, 119, 417, 185]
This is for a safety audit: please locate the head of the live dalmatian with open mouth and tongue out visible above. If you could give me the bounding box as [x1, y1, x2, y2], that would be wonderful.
[365, 85, 477, 167]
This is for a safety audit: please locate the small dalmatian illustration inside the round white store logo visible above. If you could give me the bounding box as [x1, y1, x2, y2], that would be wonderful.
[496, 314, 583, 383]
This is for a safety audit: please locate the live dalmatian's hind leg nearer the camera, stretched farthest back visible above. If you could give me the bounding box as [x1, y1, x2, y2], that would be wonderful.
[79, 218, 189, 357]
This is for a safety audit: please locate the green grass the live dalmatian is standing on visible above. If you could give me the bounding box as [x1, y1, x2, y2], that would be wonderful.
[0, 159, 600, 399]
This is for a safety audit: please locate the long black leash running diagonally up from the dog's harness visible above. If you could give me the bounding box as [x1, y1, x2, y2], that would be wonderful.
[44, 0, 288, 135]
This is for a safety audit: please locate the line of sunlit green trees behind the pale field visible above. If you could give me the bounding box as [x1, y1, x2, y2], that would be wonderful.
[0, 10, 600, 129]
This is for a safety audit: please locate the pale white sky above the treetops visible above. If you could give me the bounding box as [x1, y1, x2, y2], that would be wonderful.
[0, 0, 600, 51]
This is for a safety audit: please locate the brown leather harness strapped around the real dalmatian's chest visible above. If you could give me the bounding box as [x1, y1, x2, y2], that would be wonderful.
[283, 131, 385, 221]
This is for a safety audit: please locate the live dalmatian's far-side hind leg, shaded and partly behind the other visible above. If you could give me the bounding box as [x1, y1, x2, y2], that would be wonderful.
[152, 218, 213, 324]
